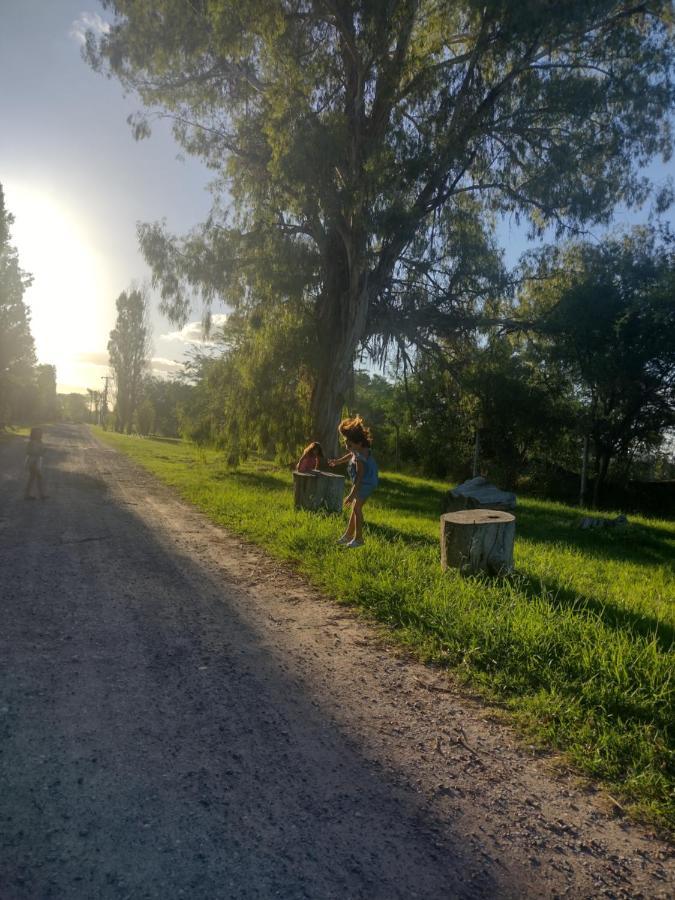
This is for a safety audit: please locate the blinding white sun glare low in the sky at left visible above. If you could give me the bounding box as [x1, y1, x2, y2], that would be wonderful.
[4, 184, 111, 390]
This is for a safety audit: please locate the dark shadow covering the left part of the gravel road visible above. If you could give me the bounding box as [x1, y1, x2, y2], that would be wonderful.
[0, 461, 508, 898]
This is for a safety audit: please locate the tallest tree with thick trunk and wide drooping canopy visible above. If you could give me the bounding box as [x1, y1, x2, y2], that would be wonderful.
[86, 0, 673, 447]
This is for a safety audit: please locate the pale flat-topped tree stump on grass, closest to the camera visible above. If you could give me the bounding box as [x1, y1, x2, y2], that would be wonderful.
[441, 509, 516, 575]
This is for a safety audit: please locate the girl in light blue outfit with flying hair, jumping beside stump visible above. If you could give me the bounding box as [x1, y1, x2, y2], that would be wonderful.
[328, 416, 377, 549]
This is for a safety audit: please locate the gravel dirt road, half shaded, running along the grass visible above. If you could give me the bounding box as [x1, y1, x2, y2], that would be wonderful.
[0, 426, 673, 900]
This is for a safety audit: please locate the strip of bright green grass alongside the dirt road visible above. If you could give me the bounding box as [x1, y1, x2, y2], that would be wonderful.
[97, 429, 675, 828]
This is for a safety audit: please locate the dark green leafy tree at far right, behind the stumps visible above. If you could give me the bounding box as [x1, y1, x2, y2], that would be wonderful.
[523, 229, 675, 503]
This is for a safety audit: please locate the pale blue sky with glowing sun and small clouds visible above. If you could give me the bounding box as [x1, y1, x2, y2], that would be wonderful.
[0, 0, 674, 393]
